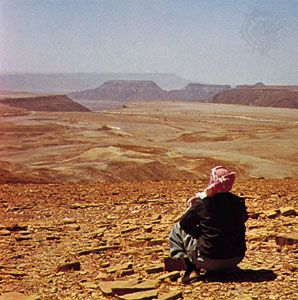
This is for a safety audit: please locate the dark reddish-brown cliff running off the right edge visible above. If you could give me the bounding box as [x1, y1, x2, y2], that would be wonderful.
[208, 83, 298, 108]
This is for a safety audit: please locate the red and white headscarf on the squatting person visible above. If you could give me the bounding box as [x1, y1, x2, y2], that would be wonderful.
[197, 166, 235, 198]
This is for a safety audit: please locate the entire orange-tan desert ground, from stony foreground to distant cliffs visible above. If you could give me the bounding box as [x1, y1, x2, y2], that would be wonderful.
[0, 101, 298, 300]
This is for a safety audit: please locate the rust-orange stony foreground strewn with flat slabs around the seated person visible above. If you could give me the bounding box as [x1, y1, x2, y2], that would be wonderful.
[0, 179, 298, 300]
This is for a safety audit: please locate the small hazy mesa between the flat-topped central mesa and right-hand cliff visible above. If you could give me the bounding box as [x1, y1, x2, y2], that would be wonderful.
[169, 83, 231, 101]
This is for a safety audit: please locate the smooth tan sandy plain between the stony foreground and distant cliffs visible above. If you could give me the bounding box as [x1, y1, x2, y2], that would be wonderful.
[0, 101, 298, 182]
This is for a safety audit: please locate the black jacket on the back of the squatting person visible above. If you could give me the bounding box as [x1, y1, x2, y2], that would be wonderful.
[180, 193, 247, 259]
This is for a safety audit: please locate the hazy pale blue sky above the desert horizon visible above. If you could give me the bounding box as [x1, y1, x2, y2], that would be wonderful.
[0, 0, 298, 85]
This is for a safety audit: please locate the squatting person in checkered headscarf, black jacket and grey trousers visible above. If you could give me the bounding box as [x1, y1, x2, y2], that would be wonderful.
[169, 166, 247, 283]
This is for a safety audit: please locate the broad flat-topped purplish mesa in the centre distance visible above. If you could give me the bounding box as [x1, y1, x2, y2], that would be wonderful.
[69, 80, 168, 101]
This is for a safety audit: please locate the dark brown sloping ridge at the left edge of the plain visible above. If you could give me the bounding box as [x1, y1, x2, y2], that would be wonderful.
[0, 95, 89, 112]
